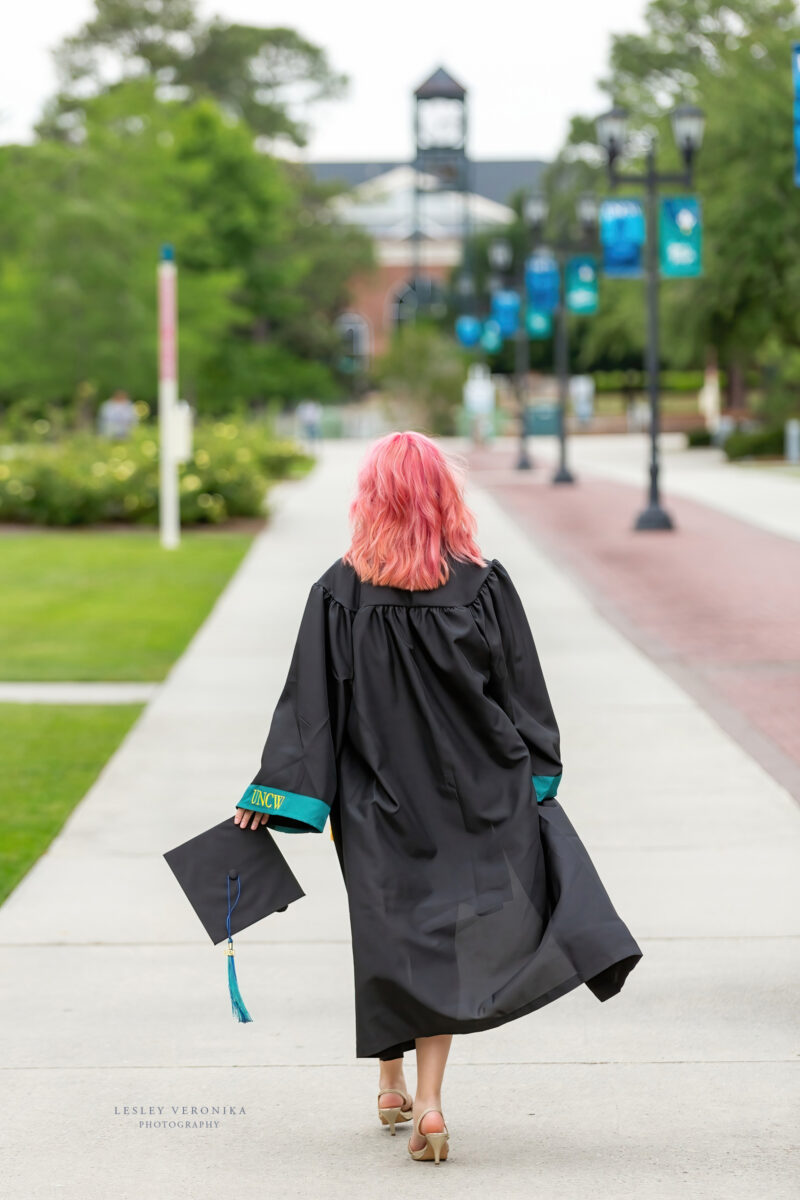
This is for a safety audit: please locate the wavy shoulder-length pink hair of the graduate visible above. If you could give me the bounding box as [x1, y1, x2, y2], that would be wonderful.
[342, 431, 485, 592]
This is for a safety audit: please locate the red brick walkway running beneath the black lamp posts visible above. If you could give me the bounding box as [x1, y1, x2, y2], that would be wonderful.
[469, 450, 800, 799]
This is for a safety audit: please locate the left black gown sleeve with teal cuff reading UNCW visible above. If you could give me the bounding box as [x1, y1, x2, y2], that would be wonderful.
[236, 582, 351, 833]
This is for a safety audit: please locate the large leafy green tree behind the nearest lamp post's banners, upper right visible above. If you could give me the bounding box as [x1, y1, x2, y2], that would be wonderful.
[556, 0, 800, 412]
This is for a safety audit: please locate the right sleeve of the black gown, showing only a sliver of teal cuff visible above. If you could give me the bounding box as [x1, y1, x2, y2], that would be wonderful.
[482, 559, 561, 803]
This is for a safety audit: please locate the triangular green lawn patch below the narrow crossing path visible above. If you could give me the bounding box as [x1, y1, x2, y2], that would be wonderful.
[0, 704, 142, 904]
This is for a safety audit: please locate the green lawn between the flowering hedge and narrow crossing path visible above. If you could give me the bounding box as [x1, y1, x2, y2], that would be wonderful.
[0, 530, 252, 682]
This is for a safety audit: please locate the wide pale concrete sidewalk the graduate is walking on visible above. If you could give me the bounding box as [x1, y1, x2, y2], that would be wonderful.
[0, 443, 800, 1200]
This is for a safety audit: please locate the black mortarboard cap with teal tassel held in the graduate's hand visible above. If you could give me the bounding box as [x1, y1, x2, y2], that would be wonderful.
[164, 817, 306, 1021]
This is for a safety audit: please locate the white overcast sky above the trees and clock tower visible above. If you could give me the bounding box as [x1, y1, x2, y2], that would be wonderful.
[0, 0, 646, 160]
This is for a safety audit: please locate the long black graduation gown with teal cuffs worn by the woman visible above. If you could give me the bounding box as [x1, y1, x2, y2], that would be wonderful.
[240, 559, 642, 1057]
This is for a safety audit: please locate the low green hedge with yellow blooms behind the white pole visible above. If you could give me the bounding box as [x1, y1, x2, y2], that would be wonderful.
[0, 421, 313, 526]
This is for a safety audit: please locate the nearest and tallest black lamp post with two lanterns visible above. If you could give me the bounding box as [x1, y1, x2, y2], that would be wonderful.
[595, 104, 705, 529]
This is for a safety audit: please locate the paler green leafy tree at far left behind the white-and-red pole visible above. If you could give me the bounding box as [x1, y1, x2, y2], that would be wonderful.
[0, 84, 240, 400]
